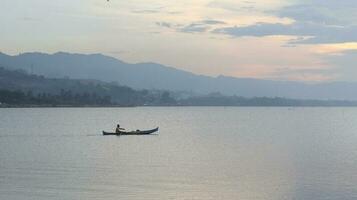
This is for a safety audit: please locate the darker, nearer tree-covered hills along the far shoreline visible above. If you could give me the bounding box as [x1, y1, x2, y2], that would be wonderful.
[0, 67, 357, 107]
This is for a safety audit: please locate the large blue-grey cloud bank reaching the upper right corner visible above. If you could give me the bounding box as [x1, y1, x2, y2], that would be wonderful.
[212, 0, 357, 44]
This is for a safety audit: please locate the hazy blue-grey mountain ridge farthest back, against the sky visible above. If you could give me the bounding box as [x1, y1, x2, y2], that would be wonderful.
[0, 52, 357, 100]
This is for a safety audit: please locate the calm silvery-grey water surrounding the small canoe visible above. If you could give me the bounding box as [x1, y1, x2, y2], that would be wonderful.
[0, 107, 357, 200]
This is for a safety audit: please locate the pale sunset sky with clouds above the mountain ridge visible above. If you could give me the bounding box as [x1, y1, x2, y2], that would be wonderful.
[0, 0, 357, 81]
